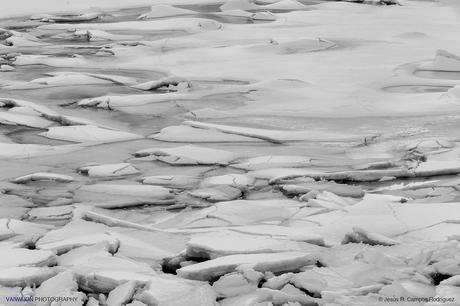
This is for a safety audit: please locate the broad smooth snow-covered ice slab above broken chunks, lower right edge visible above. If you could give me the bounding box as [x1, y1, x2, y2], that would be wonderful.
[302, 194, 460, 244]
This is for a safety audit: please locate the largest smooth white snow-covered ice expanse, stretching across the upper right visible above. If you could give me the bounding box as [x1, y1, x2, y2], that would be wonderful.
[37, 2, 459, 116]
